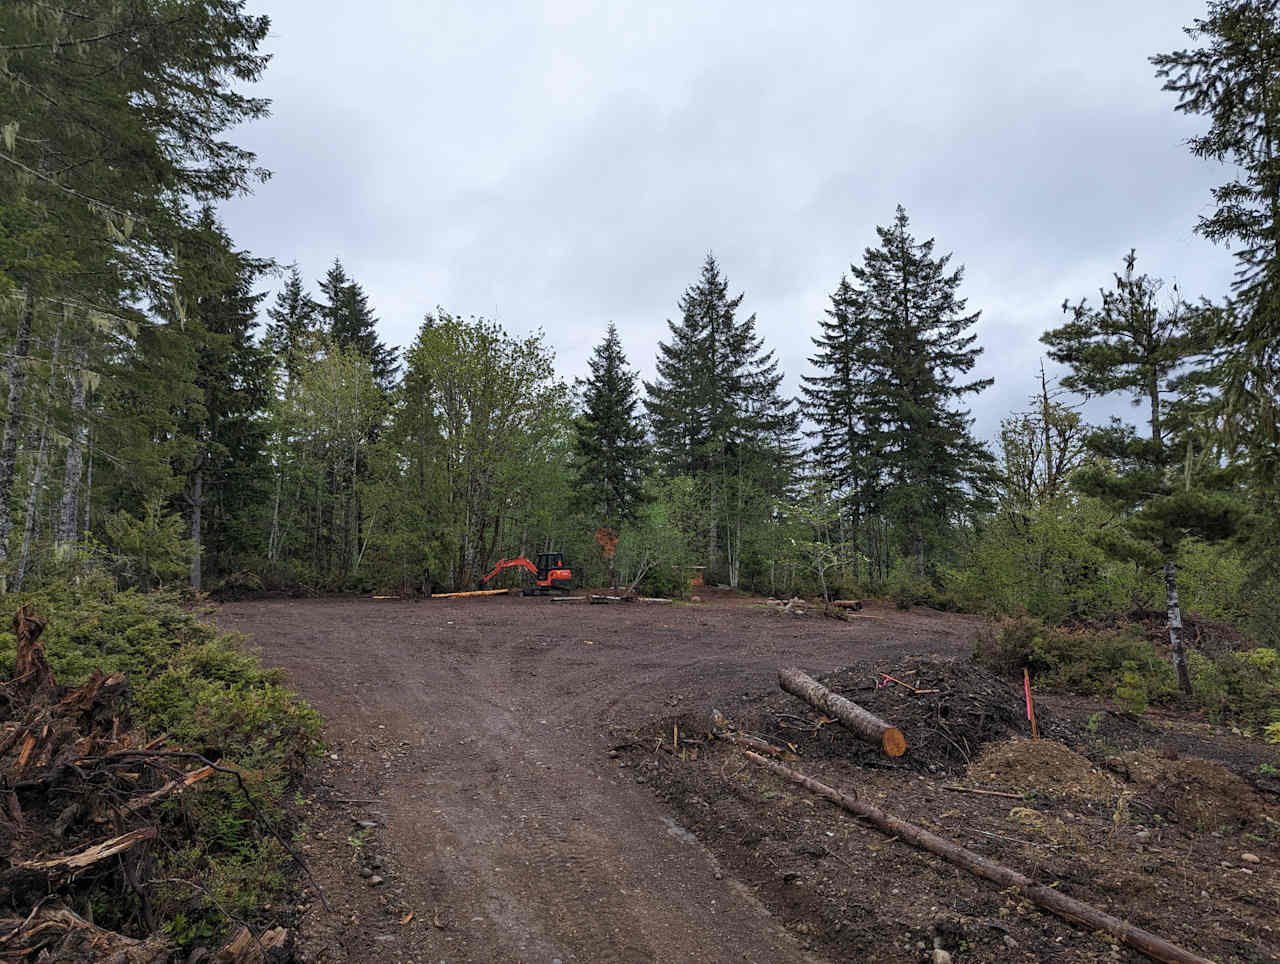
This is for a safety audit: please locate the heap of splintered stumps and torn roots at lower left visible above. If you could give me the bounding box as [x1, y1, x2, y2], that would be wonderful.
[0, 607, 285, 964]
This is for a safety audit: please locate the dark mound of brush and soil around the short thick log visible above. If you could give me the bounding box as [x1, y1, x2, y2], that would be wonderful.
[726, 657, 1071, 772]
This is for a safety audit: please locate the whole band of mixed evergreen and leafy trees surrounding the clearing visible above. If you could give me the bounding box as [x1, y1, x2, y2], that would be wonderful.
[0, 0, 1280, 652]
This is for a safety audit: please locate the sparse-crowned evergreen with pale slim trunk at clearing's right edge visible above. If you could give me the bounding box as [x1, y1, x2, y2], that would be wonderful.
[1041, 251, 1240, 693]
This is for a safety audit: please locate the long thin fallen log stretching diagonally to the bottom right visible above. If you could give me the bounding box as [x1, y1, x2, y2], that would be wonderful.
[744, 750, 1211, 964]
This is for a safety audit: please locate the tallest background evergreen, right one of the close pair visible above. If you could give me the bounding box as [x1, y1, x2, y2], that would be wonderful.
[849, 205, 992, 570]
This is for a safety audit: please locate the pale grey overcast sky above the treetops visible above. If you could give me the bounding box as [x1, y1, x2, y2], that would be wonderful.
[224, 0, 1231, 438]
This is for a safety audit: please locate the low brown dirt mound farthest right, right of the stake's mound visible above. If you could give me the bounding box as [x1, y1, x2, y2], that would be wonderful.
[1120, 750, 1267, 830]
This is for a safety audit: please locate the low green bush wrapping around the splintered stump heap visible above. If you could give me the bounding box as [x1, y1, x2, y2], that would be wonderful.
[0, 574, 321, 944]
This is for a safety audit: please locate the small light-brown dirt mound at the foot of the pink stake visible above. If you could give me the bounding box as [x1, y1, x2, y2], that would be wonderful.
[969, 740, 1119, 800]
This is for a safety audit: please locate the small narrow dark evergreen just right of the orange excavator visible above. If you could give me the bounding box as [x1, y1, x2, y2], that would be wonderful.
[573, 321, 645, 531]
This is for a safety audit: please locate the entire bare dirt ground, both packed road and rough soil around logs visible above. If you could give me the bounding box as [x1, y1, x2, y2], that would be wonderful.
[215, 594, 1280, 963]
